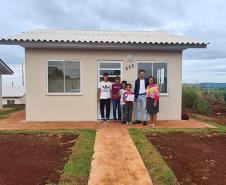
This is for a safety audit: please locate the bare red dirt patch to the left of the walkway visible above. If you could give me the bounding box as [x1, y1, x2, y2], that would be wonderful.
[0, 134, 77, 185]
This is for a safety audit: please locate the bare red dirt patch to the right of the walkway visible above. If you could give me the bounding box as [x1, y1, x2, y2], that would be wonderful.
[149, 133, 226, 185]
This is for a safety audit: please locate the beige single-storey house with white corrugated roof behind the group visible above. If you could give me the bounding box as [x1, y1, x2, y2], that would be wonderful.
[0, 29, 208, 121]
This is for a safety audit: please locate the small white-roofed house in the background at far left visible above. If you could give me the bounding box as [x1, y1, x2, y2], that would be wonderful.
[2, 86, 25, 105]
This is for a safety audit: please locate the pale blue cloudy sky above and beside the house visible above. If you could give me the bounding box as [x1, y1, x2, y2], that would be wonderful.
[0, 0, 226, 85]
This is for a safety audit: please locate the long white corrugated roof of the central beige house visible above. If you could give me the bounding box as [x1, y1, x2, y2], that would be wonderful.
[0, 29, 208, 47]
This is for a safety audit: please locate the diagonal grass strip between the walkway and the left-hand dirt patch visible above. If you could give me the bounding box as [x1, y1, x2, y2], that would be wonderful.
[60, 130, 96, 185]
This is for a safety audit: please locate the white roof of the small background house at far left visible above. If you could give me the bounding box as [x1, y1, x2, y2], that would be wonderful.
[2, 86, 25, 98]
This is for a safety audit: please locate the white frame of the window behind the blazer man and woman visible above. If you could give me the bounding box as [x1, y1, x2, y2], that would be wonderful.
[136, 60, 169, 96]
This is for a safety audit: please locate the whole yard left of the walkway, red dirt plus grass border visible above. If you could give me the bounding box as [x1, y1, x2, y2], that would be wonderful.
[0, 129, 95, 185]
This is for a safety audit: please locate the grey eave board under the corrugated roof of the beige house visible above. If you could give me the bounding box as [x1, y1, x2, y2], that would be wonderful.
[0, 40, 208, 50]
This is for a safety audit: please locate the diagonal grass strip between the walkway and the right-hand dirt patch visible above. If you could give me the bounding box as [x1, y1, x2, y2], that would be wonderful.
[129, 129, 177, 185]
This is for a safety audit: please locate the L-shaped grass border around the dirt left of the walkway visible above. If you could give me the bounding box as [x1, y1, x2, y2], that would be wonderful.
[0, 129, 96, 185]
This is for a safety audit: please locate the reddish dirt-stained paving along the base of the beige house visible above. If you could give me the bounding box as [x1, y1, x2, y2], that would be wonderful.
[0, 111, 213, 130]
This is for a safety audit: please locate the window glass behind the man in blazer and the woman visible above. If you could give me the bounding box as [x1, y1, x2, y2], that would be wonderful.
[137, 61, 168, 93]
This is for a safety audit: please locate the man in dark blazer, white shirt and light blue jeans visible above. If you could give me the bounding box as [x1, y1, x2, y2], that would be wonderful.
[134, 69, 148, 125]
